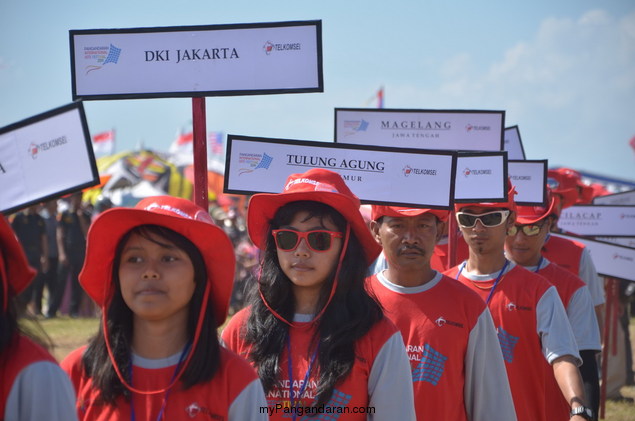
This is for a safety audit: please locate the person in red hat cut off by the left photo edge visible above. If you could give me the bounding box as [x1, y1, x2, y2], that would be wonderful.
[0, 215, 77, 421]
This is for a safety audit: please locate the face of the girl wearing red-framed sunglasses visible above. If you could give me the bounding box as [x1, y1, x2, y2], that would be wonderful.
[276, 211, 343, 304]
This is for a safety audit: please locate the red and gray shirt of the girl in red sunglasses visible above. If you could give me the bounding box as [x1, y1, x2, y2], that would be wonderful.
[222, 308, 415, 421]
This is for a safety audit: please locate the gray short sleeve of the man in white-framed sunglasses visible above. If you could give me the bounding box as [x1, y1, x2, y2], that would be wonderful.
[536, 286, 582, 366]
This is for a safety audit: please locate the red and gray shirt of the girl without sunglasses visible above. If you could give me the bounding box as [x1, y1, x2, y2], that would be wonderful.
[62, 347, 267, 421]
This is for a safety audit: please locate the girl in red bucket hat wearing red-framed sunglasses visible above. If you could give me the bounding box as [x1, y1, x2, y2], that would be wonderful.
[222, 169, 415, 420]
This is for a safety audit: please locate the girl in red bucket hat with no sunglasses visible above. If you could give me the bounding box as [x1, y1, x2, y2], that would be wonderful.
[62, 196, 266, 421]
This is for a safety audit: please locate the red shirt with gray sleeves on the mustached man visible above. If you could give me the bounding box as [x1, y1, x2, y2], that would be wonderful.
[367, 272, 516, 421]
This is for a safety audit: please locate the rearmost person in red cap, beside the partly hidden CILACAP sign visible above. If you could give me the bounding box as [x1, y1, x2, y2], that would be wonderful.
[542, 168, 606, 332]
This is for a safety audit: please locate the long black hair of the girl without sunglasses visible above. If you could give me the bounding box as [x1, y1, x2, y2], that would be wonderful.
[82, 225, 220, 405]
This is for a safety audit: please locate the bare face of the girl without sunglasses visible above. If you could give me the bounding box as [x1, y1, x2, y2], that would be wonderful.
[119, 233, 196, 322]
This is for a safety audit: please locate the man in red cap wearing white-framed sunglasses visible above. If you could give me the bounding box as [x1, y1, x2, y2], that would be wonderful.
[446, 183, 592, 421]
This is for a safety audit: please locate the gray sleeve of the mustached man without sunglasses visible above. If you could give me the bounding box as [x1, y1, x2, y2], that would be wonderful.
[463, 308, 516, 421]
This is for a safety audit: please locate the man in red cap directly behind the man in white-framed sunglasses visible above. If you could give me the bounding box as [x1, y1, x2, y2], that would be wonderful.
[505, 194, 602, 421]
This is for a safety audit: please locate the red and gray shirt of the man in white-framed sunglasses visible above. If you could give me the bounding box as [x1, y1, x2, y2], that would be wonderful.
[446, 262, 581, 421]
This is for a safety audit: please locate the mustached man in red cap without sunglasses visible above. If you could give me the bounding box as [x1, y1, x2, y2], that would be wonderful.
[367, 206, 516, 420]
